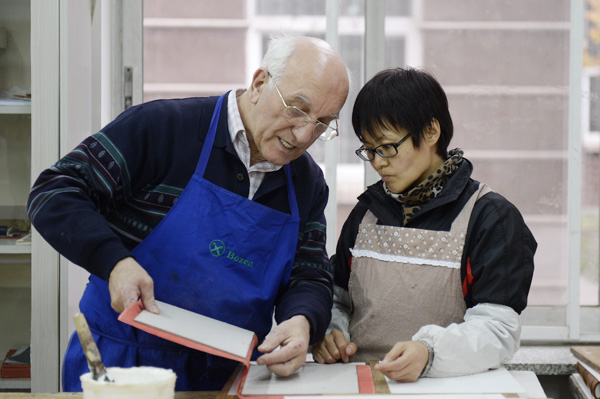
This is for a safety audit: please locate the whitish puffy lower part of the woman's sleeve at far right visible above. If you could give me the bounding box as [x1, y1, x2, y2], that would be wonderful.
[412, 303, 521, 377]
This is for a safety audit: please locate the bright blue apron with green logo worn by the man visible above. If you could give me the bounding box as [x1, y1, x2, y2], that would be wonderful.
[63, 94, 300, 392]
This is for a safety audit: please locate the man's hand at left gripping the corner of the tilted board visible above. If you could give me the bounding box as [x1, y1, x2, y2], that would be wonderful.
[108, 257, 159, 314]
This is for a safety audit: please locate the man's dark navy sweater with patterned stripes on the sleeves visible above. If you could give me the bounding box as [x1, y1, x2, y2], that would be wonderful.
[28, 97, 332, 343]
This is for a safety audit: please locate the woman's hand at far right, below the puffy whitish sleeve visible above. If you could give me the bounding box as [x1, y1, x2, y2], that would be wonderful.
[375, 341, 429, 382]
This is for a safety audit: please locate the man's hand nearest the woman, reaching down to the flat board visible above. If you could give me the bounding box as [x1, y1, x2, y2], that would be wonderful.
[256, 316, 310, 377]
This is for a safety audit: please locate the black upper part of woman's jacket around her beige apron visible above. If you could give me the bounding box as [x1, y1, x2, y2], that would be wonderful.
[332, 158, 537, 313]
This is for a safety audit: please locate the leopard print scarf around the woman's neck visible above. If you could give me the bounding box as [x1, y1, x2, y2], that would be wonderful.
[383, 148, 464, 226]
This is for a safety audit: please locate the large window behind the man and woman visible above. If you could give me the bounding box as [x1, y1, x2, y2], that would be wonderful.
[144, 0, 600, 341]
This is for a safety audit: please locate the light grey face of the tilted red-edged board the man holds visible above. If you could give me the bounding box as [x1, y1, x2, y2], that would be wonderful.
[135, 301, 254, 358]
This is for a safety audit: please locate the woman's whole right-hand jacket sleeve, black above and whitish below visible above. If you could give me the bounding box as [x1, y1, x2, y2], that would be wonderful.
[413, 193, 537, 377]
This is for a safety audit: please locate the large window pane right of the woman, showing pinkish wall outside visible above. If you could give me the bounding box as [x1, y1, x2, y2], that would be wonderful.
[422, 0, 569, 306]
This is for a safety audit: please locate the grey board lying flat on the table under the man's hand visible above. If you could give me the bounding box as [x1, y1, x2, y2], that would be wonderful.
[229, 363, 360, 399]
